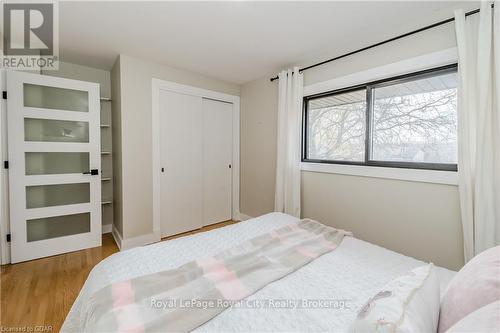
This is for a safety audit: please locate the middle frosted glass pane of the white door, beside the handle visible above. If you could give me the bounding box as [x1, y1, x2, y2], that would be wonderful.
[25, 152, 90, 175]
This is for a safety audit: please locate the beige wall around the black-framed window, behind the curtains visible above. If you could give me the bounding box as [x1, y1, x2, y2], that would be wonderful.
[240, 24, 463, 269]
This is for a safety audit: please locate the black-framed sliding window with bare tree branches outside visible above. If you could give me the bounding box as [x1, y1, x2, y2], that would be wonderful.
[302, 65, 457, 171]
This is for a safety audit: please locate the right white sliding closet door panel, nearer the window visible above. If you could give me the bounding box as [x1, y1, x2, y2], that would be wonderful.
[203, 98, 233, 225]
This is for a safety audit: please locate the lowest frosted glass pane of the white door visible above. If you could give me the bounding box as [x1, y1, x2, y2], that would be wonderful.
[26, 213, 90, 242]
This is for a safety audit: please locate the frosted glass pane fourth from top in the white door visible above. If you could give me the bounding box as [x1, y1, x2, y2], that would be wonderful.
[26, 183, 90, 209]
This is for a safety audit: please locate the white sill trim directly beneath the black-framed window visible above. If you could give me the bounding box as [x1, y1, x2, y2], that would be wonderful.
[300, 162, 458, 186]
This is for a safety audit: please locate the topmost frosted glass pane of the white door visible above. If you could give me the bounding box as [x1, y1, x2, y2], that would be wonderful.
[23, 83, 89, 112]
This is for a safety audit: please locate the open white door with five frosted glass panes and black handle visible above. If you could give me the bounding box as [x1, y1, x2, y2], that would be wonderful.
[7, 72, 101, 263]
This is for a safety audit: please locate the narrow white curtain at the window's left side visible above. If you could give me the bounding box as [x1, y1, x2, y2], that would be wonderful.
[274, 67, 304, 217]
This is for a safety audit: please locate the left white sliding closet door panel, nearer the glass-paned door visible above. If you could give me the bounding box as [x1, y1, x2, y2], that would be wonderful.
[159, 90, 203, 237]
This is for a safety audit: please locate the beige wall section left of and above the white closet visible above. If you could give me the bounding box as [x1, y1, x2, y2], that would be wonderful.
[113, 55, 240, 241]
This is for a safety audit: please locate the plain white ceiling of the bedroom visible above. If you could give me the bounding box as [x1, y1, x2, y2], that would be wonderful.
[59, 1, 479, 84]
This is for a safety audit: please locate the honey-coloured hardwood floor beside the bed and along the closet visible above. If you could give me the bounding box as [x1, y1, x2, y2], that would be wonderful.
[0, 221, 236, 332]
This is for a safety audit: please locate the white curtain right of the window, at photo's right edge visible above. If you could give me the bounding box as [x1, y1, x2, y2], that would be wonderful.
[455, 1, 500, 261]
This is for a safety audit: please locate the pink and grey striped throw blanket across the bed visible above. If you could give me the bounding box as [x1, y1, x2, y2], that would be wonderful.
[84, 219, 351, 333]
